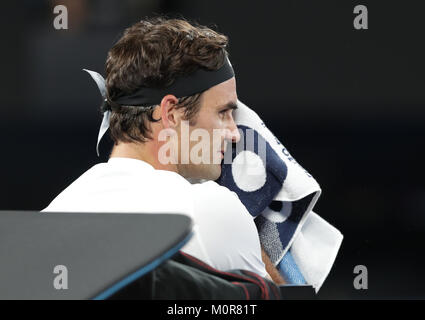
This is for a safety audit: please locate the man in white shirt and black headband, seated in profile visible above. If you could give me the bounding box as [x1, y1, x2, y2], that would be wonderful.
[44, 18, 281, 282]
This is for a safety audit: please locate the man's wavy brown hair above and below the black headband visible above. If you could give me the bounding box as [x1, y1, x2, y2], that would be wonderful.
[102, 17, 228, 144]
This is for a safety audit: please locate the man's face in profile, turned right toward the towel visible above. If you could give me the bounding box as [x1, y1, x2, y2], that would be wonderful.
[177, 77, 240, 180]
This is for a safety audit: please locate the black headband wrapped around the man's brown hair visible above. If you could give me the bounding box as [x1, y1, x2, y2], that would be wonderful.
[108, 58, 235, 106]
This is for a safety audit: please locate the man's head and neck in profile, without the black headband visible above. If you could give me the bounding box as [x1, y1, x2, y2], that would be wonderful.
[106, 18, 239, 180]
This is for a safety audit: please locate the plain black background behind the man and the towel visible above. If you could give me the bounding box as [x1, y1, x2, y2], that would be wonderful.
[0, 0, 425, 299]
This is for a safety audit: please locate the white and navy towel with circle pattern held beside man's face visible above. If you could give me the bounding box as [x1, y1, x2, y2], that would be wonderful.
[217, 101, 343, 292]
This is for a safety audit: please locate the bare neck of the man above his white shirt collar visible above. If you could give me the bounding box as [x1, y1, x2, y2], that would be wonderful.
[110, 142, 177, 172]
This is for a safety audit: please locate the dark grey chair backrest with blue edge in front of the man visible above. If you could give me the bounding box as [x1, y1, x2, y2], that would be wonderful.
[0, 211, 192, 299]
